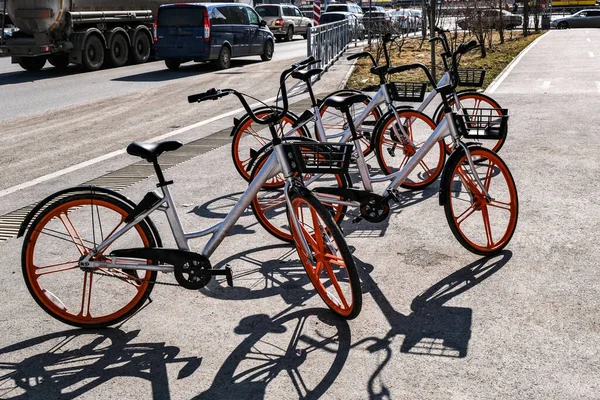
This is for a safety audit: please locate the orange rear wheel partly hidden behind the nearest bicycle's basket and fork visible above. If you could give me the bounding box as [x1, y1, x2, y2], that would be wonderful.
[250, 138, 352, 243]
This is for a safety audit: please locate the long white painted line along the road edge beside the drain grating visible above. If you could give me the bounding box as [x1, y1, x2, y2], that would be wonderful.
[0, 97, 277, 197]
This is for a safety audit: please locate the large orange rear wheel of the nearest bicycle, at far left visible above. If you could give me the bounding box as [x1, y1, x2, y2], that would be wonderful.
[22, 192, 156, 328]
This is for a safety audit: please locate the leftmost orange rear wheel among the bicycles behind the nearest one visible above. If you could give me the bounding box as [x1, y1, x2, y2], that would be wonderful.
[231, 109, 307, 182]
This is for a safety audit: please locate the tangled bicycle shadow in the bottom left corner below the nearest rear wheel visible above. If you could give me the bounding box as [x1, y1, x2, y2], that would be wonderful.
[0, 328, 202, 400]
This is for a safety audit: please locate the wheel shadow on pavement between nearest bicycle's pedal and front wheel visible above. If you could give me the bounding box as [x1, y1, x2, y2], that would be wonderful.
[200, 244, 317, 307]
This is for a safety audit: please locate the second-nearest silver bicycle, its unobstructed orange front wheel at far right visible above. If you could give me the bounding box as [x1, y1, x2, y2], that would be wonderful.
[247, 41, 518, 255]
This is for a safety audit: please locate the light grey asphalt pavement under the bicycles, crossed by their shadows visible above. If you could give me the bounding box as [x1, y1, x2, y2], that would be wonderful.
[0, 30, 600, 400]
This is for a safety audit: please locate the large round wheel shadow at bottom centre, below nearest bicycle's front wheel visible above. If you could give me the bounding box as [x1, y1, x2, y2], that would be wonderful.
[195, 307, 351, 399]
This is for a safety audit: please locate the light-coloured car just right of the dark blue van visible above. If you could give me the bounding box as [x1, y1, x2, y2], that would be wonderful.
[256, 4, 313, 41]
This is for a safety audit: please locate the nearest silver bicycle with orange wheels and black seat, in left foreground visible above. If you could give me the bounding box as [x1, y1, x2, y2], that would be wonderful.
[19, 61, 362, 328]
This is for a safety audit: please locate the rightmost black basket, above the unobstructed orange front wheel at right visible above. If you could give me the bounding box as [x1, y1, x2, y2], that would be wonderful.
[455, 108, 508, 140]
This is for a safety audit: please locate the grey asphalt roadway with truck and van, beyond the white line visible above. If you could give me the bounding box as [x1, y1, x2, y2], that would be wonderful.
[0, 40, 306, 199]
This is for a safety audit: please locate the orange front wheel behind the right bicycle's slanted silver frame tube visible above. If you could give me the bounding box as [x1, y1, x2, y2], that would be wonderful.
[374, 109, 446, 190]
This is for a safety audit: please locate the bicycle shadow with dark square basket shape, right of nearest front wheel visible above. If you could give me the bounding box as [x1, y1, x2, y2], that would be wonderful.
[352, 250, 512, 399]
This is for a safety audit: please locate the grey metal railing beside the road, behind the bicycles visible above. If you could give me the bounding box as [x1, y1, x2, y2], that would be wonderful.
[306, 21, 356, 70]
